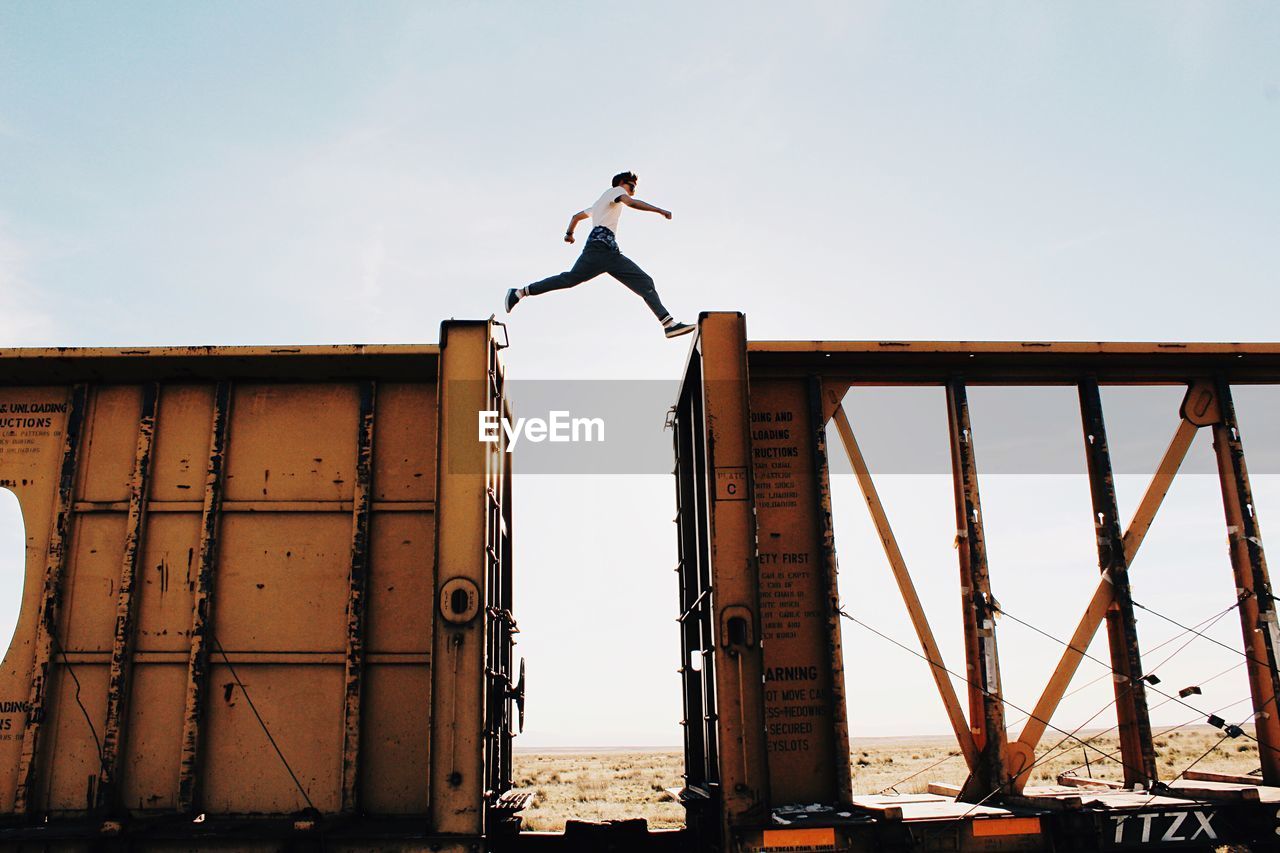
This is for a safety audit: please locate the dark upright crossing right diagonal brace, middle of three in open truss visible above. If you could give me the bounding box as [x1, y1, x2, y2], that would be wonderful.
[1079, 378, 1157, 788]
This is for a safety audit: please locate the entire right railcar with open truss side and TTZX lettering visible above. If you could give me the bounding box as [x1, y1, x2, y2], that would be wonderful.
[671, 313, 1280, 853]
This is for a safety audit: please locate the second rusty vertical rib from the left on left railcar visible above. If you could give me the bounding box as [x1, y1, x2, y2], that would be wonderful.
[97, 383, 160, 807]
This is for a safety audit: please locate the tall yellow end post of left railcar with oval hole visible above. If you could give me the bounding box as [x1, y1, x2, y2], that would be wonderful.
[429, 321, 492, 836]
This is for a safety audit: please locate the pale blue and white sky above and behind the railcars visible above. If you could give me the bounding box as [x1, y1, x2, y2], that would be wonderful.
[0, 0, 1280, 745]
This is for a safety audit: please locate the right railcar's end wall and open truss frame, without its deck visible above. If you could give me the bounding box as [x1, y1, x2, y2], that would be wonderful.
[672, 313, 1280, 849]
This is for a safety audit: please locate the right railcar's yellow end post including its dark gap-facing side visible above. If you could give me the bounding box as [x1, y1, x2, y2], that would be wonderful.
[672, 314, 772, 849]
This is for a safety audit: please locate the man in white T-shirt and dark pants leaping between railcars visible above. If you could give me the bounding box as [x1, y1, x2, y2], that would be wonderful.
[507, 172, 694, 338]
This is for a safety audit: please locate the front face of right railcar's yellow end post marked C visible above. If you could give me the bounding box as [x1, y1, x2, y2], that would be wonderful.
[698, 313, 769, 850]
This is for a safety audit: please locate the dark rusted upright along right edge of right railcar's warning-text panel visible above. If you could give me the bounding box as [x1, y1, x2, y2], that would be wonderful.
[809, 375, 854, 803]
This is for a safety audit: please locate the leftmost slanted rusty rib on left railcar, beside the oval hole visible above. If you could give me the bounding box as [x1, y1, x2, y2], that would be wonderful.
[14, 384, 88, 815]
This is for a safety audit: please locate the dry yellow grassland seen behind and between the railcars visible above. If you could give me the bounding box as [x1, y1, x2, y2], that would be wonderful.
[515, 726, 1258, 830]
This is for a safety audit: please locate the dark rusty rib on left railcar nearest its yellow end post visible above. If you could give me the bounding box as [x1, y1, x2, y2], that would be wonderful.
[342, 382, 378, 812]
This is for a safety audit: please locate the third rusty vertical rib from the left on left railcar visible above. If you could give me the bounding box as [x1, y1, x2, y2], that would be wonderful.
[178, 382, 232, 812]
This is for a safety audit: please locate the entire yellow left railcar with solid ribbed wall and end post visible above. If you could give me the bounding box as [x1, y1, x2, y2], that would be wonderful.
[0, 321, 522, 850]
